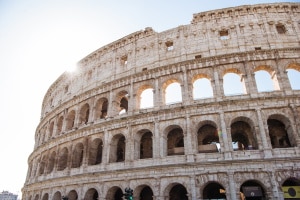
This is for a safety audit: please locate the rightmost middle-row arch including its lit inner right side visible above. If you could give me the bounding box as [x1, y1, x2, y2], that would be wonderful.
[267, 114, 296, 148]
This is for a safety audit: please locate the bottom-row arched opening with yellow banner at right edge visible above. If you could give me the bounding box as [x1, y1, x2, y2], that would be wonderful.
[282, 177, 300, 200]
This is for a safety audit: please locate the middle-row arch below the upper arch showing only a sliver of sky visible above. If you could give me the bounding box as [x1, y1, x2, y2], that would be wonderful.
[109, 134, 126, 162]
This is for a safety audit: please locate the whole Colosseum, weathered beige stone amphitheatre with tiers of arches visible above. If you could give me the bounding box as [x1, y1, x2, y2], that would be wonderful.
[22, 3, 300, 200]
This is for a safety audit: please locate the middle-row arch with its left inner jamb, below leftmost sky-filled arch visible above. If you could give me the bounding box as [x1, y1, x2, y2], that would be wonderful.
[138, 129, 153, 159]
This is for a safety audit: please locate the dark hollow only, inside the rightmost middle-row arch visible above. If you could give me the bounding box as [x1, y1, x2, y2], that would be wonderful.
[267, 116, 292, 148]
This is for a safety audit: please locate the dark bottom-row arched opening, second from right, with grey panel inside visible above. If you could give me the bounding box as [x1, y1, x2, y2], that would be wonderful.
[240, 180, 267, 200]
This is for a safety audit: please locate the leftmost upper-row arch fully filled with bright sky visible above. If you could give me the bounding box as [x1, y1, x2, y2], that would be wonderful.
[137, 85, 154, 109]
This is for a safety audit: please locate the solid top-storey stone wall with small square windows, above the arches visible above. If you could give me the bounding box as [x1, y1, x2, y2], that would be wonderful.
[42, 3, 300, 117]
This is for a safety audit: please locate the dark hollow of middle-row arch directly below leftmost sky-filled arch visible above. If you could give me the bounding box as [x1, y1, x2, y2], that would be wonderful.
[140, 131, 153, 159]
